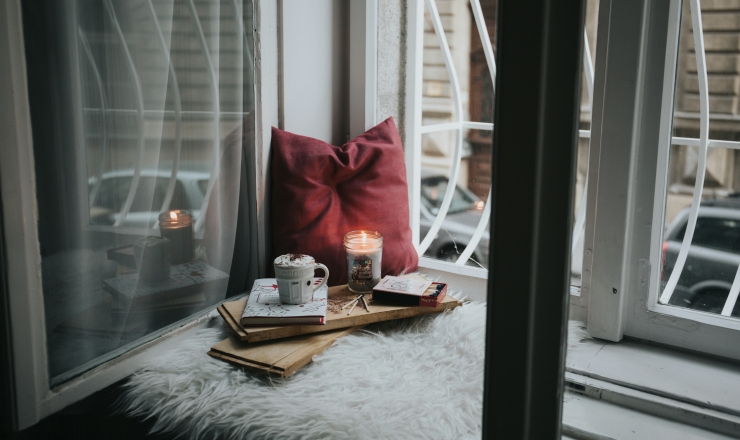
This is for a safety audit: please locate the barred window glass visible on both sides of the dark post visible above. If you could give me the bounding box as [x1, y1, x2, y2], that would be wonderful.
[419, 0, 598, 276]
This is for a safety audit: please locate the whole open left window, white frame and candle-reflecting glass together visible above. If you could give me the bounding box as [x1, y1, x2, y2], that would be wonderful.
[0, 0, 277, 427]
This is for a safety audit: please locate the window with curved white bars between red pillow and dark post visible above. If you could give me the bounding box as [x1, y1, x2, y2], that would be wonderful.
[408, 0, 496, 278]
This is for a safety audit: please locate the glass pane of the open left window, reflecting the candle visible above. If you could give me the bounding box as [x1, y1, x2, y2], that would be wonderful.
[23, 0, 254, 385]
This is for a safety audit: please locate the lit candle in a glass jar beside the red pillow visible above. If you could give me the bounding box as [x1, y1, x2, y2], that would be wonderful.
[344, 231, 383, 293]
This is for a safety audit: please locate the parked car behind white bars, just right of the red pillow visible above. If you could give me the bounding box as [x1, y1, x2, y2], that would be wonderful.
[420, 170, 489, 268]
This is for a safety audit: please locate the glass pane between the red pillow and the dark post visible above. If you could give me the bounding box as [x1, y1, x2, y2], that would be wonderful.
[420, 0, 496, 268]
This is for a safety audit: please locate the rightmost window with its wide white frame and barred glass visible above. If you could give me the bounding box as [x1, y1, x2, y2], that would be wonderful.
[581, 0, 740, 359]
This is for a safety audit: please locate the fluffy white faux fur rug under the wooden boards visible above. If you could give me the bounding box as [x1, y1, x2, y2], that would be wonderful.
[120, 303, 587, 439]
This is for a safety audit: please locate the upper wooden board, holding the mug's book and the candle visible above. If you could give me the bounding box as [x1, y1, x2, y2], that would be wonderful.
[217, 278, 462, 342]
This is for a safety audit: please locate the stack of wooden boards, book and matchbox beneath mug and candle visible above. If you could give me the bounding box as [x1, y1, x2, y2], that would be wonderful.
[208, 275, 461, 377]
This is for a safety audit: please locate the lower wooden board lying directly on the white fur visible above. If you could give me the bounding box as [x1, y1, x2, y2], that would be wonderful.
[208, 326, 362, 377]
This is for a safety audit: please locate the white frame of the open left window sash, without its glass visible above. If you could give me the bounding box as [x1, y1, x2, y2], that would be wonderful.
[0, 0, 279, 429]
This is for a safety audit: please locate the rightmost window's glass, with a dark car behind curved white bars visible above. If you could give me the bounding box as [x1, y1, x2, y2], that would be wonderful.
[660, 0, 740, 316]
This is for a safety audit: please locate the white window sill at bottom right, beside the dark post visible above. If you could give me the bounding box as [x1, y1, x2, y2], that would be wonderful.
[563, 339, 740, 438]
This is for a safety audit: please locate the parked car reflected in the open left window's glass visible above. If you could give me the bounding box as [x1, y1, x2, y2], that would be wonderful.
[88, 162, 210, 228]
